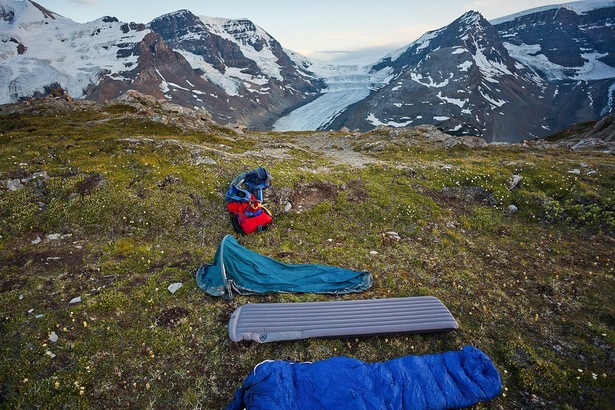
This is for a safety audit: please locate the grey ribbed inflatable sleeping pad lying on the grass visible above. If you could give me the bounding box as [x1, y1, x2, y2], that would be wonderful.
[229, 296, 458, 343]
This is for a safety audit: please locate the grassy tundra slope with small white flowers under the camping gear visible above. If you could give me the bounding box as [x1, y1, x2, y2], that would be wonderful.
[0, 100, 615, 409]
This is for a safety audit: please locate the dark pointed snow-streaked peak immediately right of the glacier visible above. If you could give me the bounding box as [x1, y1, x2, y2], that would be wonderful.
[331, 12, 548, 141]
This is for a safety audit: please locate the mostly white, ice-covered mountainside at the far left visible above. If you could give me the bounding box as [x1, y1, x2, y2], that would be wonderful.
[0, 0, 147, 103]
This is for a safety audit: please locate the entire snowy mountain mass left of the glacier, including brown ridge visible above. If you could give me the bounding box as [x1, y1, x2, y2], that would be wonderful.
[0, 0, 323, 129]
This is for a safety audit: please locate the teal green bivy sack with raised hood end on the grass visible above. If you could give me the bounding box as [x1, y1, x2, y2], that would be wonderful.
[196, 235, 373, 299]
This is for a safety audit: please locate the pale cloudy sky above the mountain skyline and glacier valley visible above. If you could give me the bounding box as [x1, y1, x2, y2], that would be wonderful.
[36, 0, 588, 63]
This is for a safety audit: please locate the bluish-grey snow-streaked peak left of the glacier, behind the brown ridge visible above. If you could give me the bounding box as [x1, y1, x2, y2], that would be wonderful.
[150, 10, 323, 130]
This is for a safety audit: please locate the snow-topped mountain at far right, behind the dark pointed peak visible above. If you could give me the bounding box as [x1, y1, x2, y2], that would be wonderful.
[492, 1, 615, 139]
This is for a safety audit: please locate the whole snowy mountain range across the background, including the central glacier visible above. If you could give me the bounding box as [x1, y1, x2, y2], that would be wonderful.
[0, 0, 615, 142]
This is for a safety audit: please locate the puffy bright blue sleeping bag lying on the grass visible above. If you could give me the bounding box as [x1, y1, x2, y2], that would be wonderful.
[227, 346, 502, 410]
